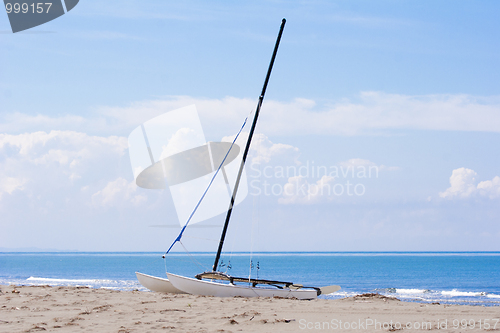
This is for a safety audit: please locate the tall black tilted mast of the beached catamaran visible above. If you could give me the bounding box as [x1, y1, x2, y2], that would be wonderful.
[212, 19, 286, 272]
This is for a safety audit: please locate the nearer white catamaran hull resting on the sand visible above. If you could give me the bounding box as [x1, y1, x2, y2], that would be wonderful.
[167, 273, 318, 299]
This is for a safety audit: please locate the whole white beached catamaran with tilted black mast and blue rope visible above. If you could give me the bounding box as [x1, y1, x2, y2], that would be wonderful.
[136, 19, 340, 299]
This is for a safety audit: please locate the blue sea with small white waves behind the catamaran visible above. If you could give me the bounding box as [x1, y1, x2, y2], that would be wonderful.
[0, 252, 500, 306]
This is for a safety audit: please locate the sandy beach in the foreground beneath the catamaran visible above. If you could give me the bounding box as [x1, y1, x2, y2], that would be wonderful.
[0, 286, 500, 333]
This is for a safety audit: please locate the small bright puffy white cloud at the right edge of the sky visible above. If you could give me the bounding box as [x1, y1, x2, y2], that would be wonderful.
[439, 168, 500, 199]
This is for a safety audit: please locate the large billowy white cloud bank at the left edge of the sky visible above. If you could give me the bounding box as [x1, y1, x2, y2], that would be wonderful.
[0, 131, 131, 207]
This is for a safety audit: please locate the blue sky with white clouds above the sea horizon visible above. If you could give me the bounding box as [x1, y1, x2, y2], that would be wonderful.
[0, 0, 500, 251]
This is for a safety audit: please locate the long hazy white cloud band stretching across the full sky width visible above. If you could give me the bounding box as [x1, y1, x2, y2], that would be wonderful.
[0, 92, 500, 138]
